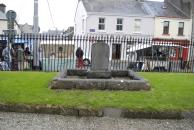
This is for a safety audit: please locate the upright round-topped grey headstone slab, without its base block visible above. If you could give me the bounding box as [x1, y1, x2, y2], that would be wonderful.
[91, 42, 110, 71]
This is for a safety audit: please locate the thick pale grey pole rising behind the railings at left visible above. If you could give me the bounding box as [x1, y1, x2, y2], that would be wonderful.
[33, 0, 40, 70]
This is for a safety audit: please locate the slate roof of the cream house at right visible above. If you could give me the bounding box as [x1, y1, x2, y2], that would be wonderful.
[144, 1, 188, 18]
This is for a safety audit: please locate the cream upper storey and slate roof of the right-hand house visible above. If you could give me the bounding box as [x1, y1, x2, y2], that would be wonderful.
[145, 1, 192, 40]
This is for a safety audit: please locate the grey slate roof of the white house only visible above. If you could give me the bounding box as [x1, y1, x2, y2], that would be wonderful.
[82, 0, 149, 15]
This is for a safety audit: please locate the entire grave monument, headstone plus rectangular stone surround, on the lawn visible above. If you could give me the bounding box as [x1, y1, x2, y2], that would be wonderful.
[50, 41, 150, 91]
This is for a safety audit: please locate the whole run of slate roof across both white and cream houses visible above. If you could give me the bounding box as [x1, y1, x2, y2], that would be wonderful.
[82, 0, 188, 18]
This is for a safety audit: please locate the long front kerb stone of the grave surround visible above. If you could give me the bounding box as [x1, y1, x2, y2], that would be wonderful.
[51, 78, 150, 91]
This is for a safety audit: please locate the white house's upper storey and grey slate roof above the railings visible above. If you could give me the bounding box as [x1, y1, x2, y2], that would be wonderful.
[75, 0, 154, 36]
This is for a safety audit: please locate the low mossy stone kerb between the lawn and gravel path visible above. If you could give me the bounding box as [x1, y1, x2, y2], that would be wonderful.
[0, 104, 194, 120]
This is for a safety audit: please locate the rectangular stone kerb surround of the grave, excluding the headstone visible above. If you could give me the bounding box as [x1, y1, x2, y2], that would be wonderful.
[50, 70, 151, 91]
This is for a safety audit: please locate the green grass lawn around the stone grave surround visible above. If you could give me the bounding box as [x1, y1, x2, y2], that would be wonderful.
[0, 72, 194, 111]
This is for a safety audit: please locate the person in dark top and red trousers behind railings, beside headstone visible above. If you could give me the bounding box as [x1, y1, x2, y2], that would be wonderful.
[76, 47, 84, 68]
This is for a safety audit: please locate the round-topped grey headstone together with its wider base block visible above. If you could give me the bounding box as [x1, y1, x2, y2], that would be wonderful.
[87, 42, 111, 79]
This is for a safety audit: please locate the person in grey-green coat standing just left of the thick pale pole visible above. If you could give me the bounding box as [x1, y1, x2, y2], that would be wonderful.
[17, 45, 24, 71]
